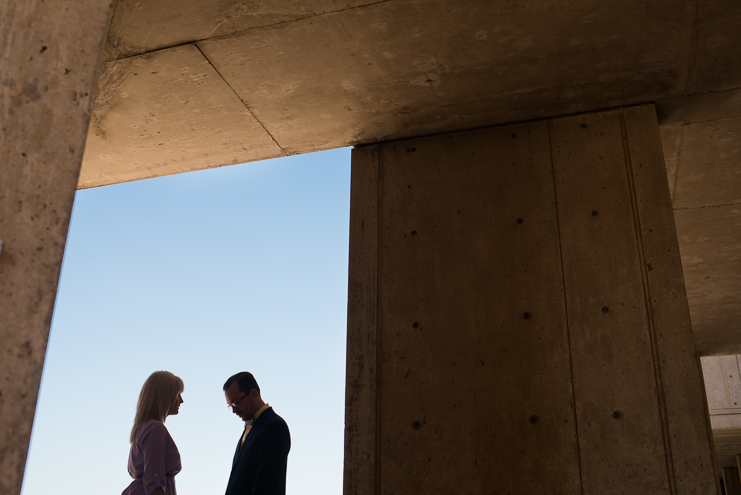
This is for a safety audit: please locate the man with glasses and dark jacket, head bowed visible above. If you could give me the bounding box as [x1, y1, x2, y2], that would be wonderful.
[224, 371, 291, 495]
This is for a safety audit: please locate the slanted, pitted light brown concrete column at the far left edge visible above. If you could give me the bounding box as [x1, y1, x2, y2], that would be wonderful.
[0, 0, 112, 495]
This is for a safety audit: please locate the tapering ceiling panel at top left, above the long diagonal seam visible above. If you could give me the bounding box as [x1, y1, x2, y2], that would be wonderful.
[104, 0, 375, 60]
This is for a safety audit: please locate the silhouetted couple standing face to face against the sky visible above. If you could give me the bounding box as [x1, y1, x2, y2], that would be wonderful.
[122, 371, 291, 495]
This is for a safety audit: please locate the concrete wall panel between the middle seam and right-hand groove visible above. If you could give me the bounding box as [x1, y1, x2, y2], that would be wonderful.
[550, 111, 676, 494]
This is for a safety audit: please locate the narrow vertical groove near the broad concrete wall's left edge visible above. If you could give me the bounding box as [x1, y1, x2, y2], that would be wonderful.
[373, 144, 383, 495]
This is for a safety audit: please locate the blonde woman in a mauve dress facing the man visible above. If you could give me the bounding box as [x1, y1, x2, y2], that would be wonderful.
[121, 371, 185, 495]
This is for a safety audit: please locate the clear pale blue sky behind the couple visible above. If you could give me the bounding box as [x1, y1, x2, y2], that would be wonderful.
[22, 149, 350, 495]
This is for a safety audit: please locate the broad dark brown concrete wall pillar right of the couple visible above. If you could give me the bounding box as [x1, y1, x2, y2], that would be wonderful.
[345, 105, 719, 495]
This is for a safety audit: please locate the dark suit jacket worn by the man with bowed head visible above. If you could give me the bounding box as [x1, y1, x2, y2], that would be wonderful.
[226, 407, 291, 495]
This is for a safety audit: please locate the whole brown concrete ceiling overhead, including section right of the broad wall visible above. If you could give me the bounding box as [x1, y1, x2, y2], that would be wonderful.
[79, 0, 741, 354]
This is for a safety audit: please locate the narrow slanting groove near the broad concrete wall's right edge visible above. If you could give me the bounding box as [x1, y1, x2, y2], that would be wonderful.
[618, 109, 677, 494]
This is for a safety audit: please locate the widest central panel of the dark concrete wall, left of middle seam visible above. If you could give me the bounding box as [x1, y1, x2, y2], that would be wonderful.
[379, 122, 581, 494]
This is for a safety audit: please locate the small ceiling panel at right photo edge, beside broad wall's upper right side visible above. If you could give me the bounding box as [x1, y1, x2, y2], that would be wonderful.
[674, 119, 741, 209]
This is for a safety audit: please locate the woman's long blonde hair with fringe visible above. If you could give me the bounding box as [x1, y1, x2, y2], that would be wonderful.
[129, 371, 185, 444]
